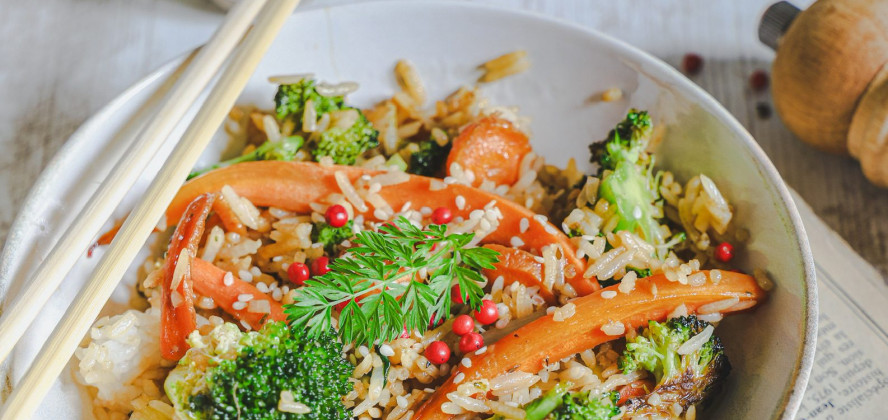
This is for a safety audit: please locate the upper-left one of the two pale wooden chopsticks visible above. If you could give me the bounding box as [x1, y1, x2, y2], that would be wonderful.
[0, 0, 265, 361]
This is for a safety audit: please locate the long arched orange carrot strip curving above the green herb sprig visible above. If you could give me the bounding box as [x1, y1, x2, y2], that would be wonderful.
[166, 161, 600, 296]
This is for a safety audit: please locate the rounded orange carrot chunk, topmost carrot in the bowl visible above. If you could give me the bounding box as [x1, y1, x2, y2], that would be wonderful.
[446, 117, 532, 187]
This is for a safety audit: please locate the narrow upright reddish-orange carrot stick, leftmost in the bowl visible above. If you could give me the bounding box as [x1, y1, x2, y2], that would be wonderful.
[160, 194, 215, 360]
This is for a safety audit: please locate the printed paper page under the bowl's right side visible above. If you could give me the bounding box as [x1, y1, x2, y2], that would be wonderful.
[795, 192, 888, 420]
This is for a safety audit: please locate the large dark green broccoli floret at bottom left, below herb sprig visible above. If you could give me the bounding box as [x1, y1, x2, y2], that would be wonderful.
[164, 322, 353, 420]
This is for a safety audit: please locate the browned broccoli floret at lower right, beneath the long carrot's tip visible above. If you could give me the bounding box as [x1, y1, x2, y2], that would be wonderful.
[619, 316, 731, 416]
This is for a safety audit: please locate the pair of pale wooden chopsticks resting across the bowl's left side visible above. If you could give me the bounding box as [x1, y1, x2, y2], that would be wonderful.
[0, 0, 299, 420]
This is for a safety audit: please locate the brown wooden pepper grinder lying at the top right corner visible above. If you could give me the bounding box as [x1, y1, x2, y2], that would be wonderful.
[759, 0, 888, 187]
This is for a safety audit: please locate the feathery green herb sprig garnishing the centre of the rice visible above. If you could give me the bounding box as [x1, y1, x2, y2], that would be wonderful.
[285, 217, 499, 345]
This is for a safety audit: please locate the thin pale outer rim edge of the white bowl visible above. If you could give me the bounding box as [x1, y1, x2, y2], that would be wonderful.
[0, 0, 818, 419]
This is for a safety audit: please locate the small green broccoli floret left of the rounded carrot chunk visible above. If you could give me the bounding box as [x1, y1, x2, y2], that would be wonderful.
[311, 109, 379, 165]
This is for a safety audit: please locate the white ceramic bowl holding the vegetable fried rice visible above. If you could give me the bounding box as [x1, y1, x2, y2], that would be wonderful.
[0, 1, 817, 419]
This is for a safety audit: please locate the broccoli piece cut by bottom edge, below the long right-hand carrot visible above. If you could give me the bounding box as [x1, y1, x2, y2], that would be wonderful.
[524, 383, 620, 420]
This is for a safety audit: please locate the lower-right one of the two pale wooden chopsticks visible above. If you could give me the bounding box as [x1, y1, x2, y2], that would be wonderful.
[0, 0, 299, 420]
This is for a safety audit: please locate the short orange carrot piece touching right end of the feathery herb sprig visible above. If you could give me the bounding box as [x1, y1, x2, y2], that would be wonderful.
[481, 244, 555, 305]
